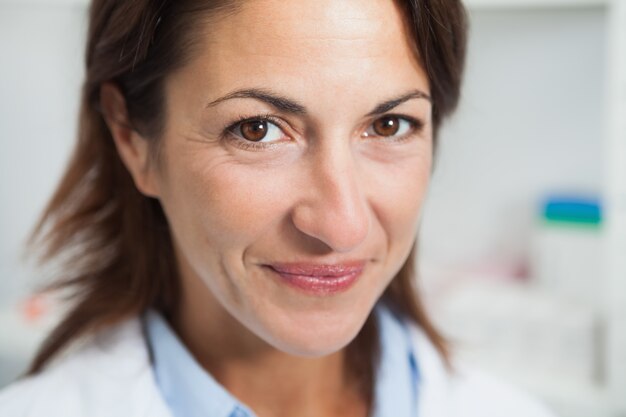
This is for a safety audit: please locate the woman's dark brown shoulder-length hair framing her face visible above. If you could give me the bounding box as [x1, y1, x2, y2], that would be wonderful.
[28, 0, 467, 404]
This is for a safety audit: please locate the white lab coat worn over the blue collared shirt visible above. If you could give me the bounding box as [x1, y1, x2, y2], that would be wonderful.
[0, 318, 553, 417]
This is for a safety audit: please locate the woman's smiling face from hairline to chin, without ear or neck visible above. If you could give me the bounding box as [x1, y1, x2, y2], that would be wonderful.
[153, 0, 432, 355]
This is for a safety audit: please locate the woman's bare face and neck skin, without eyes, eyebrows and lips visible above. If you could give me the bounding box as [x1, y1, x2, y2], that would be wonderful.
[119, 0, 432, 417]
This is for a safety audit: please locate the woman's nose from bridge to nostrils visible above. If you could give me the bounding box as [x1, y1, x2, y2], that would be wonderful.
[292, 141, 371, 253]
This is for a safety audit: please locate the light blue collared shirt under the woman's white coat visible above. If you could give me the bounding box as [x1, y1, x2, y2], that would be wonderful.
[145, 306, 419, 417]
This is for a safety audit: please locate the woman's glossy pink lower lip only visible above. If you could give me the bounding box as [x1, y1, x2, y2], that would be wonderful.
[268, 267, 363, 296]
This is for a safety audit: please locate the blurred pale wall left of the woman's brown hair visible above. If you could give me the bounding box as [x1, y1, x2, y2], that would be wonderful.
[0, 1, 86, 307]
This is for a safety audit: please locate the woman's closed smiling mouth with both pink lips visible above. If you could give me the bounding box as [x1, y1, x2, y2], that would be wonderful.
[264, 261, 365, 296]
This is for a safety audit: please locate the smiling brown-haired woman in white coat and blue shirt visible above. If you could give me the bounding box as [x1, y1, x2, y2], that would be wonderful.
[0, 0, 547, 417]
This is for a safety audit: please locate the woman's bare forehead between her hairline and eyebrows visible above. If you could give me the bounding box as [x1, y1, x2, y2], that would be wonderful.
[168, 0, 428, 111]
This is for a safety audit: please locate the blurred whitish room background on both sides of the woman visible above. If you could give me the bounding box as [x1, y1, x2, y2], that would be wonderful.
[0, 0, 626, 417]
